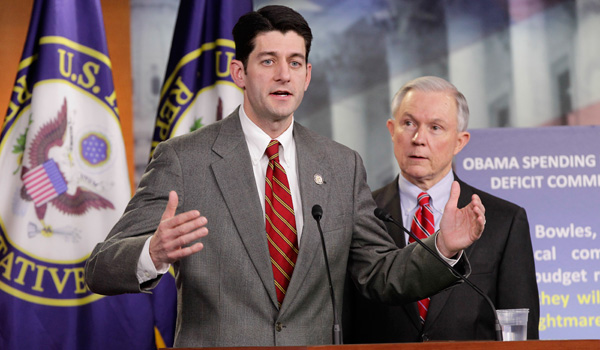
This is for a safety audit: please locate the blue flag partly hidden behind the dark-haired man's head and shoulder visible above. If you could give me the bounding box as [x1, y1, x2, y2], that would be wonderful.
[151, 0, 252, 153]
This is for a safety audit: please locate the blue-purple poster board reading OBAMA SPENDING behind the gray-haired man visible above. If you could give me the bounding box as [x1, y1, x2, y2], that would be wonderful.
[455, 126, 600, 339]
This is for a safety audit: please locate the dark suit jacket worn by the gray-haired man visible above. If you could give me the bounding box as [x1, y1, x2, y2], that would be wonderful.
[344, 176, 540, 343]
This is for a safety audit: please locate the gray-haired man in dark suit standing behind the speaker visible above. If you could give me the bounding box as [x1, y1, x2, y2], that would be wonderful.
[344, 77, 539, 343]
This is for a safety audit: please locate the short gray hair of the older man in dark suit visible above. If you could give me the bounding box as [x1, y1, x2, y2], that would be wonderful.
[392, 76, 469, 132]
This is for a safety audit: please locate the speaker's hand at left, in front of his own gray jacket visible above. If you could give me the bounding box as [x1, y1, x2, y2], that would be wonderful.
[150, 191, 208, 270]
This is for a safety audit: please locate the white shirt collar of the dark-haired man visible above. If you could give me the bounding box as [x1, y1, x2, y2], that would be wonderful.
[239, 103, 294, 165]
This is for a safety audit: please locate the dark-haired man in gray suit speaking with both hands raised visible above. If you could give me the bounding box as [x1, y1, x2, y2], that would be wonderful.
[85, 6, 485, 347]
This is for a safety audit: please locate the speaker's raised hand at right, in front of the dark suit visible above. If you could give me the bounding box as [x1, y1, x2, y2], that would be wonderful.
[437, 181, 485, 258]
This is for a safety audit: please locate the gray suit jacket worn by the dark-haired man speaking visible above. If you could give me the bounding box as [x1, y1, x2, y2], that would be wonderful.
[86, 111, 468, 347]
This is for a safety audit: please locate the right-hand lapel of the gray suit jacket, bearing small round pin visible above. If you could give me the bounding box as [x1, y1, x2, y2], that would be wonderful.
[281, 123, 332, 313]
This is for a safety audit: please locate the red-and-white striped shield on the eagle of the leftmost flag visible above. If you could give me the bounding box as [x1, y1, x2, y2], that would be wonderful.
[23, 159, 67, 207]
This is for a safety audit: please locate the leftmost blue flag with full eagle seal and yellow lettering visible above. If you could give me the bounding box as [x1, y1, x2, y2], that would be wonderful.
[0, 0, 174, 350]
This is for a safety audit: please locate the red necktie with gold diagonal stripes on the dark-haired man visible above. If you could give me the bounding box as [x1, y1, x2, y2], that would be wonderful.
[265, 140, 298, 306]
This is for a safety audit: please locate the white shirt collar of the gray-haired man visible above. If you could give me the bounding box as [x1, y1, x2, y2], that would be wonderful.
[398, 171, 454, 213]
